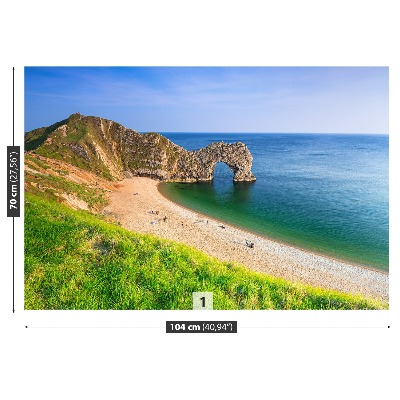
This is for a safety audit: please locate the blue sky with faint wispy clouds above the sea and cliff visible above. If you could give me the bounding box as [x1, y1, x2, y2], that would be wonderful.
[25, 67, 389, 134]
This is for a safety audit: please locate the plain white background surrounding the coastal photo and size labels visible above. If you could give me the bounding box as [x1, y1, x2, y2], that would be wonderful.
[0, 0, 400, 399]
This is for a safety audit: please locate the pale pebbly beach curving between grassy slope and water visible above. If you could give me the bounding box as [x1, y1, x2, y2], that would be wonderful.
[103, 177, 389, 301]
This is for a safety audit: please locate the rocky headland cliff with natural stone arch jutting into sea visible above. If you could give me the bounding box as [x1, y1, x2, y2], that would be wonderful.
[25, 114, 256, 182]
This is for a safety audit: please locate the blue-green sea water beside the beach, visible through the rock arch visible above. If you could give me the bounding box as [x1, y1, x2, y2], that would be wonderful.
[160, 133, 389, 271]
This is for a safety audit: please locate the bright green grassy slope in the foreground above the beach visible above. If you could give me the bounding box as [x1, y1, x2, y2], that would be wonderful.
[25, 193, 388, 310]
